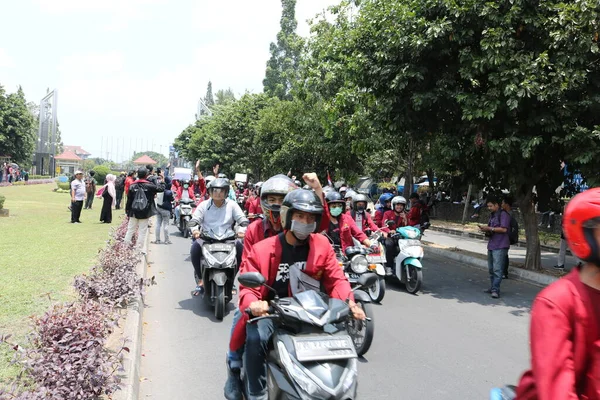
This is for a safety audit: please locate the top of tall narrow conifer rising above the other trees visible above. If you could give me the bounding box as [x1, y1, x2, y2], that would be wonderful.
[263, 0, 303, 100]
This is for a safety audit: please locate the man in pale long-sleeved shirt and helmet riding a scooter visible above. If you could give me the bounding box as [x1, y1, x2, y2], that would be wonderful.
[190, 178, 248, 296]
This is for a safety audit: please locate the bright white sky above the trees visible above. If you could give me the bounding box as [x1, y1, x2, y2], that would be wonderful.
[0, 0, 339, 161]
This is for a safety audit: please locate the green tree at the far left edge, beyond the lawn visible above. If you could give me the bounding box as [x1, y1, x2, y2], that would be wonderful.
[0, 86, 37, 165]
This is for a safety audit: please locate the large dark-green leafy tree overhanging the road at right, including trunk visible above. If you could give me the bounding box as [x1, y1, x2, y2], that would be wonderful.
[312, 0, 600, 269]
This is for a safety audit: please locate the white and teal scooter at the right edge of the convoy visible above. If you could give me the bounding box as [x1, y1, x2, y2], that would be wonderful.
[390, 226, 424, 294]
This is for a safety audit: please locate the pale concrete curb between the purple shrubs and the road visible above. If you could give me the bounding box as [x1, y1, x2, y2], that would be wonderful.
[111, 231, 150, 400]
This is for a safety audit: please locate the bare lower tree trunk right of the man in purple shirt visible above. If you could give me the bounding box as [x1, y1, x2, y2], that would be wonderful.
[518, 184, 542, 271]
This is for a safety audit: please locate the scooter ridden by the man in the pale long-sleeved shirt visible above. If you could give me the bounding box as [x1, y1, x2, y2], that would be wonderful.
[188, 220, 237, 320]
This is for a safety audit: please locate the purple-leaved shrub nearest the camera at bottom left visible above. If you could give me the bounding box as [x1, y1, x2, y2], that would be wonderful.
[0, 301, 122, 399]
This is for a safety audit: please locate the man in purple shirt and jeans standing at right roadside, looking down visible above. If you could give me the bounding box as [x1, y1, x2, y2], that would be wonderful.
[479, 196, 510, 299]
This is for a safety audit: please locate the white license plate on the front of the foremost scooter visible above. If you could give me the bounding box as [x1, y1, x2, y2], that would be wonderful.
[292, 335, 357, 362]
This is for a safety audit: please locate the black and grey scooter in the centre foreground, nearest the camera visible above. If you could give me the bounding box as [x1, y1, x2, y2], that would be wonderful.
[238, 272, 377, 400]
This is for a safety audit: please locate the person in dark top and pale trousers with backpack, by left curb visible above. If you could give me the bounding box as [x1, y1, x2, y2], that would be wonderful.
[125, 167, 165, 255]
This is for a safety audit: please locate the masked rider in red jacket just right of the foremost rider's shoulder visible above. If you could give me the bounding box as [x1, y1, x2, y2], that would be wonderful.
[326, 192, 379, 252]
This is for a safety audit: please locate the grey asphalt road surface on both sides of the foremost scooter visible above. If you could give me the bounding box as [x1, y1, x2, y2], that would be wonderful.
[140, 226, 540, 400]
